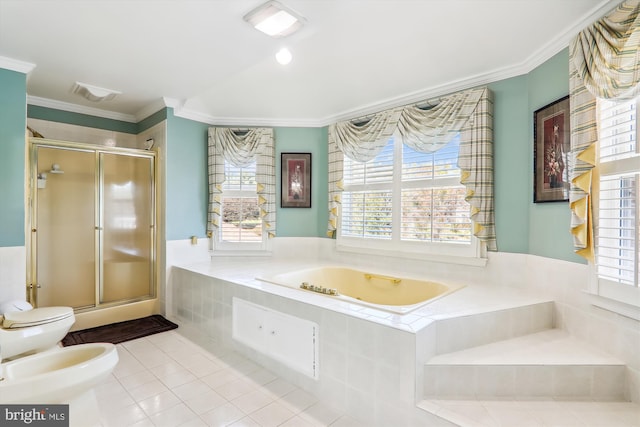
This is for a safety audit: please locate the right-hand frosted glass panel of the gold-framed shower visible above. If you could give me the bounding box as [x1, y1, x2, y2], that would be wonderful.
[100, 153, 155, 304]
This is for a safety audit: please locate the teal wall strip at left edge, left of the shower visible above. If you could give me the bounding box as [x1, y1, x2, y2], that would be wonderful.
[0, 69, 27, 247]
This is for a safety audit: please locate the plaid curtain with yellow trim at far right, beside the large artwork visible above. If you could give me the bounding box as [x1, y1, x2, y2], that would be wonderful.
[569, 0, 640, 261]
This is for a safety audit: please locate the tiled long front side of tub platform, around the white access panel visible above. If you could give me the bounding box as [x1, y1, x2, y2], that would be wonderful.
[171, 262, 436, 425]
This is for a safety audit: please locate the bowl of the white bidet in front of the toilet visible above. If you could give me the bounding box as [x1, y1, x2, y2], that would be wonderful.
[0, 343, 118, 404]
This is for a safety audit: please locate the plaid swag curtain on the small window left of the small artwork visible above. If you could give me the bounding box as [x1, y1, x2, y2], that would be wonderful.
[207, 127, 276, 238]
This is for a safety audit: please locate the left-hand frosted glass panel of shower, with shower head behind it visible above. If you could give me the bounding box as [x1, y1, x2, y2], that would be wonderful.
[31, 146, 96, 308]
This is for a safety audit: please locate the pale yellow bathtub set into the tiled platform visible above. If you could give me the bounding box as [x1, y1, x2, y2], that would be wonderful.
[258, 267, 463, 314]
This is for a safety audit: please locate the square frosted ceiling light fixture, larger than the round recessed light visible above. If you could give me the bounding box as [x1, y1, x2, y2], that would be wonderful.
[243, 1, 305, 38]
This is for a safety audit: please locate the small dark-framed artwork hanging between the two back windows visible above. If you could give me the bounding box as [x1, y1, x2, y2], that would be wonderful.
[280, 153, 311, 208]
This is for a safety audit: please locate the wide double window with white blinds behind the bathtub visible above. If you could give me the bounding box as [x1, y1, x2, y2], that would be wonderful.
[338, 137, 479, 257]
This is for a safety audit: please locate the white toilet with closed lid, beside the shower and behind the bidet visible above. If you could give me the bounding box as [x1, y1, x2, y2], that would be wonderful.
[0, 301, 75, 361]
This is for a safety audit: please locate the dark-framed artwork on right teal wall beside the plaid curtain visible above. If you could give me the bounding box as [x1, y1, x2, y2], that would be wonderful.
[533, 96, 571, 203]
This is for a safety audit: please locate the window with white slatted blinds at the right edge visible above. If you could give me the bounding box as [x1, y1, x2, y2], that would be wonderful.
[596, 99, 640, 305]
